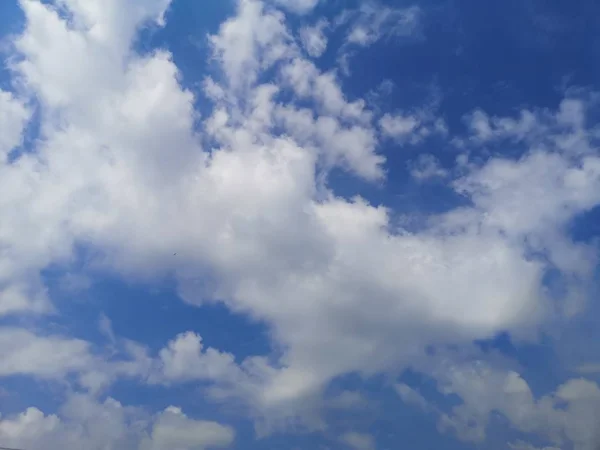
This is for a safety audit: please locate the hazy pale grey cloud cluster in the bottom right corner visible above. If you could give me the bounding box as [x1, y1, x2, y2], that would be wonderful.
[397, 361, 600, 450]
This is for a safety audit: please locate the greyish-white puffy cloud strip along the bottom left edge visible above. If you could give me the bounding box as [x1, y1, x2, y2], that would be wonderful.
[0, 394, 235, 450]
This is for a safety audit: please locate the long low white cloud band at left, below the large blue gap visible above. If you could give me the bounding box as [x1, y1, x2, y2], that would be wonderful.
[0, 324, 243, 394]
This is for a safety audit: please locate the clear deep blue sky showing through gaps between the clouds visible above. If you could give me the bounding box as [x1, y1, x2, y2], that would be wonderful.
[0, 0, 600, 450]
